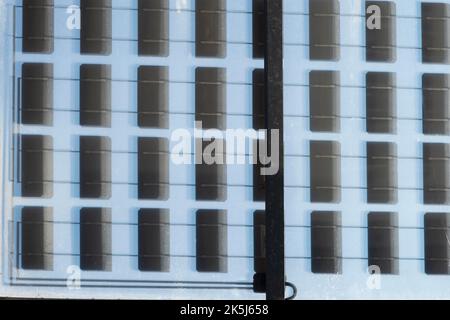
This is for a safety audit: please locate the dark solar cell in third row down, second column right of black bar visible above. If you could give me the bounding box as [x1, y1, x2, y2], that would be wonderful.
[367, 142, 398, 204]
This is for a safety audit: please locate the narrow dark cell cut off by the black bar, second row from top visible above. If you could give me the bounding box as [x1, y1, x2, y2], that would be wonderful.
[253, 69, 266, 130]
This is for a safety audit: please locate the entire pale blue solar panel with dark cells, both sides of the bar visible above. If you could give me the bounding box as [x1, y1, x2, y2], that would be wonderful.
[4, 0, 450, 298]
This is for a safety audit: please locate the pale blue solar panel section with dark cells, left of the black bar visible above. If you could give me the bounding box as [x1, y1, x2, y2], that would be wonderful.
[6, 0, 264, 298]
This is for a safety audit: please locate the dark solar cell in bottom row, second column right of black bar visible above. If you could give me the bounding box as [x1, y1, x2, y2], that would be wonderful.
[367, 212, 399, 274]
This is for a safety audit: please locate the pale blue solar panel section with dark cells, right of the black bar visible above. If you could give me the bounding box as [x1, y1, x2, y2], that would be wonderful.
[284, 0, 450, 298]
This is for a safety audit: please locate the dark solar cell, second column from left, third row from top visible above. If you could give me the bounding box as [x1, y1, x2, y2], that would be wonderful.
[80, 136, 111, 199]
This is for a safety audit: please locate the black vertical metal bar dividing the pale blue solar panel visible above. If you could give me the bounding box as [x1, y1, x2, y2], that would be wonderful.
[264, 0, 285, 300]
